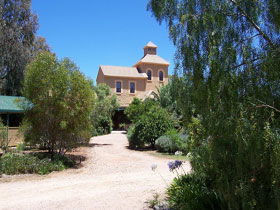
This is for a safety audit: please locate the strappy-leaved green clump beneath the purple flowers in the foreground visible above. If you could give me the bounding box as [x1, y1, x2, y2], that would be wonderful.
[167, 173, 225, 210]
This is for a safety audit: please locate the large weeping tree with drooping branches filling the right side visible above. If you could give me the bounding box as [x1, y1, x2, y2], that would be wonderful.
[148, 0, 280, 209]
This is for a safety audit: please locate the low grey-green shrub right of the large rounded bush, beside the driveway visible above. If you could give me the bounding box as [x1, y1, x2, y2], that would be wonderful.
[155, 129, 188, 154]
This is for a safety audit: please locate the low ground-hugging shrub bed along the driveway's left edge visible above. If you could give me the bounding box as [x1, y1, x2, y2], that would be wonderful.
[0, 153, 74, 175]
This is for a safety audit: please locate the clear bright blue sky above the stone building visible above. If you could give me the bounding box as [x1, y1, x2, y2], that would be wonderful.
[32, 0, 175, 83]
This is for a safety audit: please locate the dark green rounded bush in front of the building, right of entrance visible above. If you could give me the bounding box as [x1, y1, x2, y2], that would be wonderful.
[129, 105, 173, 148]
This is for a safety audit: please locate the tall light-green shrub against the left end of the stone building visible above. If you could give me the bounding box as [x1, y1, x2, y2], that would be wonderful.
[92, 84, 118, 136]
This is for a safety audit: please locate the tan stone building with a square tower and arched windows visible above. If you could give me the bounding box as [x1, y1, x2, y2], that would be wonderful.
[96, 42, 169, 107]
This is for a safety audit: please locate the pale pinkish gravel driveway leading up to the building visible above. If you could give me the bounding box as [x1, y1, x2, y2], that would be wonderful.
[0, 132, 190, 210]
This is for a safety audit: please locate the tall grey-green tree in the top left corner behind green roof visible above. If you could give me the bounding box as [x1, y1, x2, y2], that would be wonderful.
[0, 0, 38, 95]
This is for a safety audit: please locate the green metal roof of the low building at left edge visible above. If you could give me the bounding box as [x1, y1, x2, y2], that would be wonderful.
[0, 96, 25, 113]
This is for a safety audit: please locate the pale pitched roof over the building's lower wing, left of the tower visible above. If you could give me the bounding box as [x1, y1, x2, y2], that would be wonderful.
[100, 66, 148, 78]
